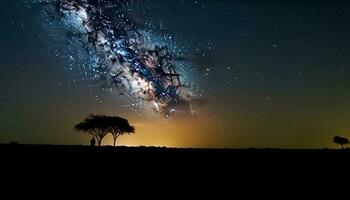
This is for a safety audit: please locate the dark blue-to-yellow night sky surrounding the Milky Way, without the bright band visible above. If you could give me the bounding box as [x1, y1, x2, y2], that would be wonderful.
[0, 0, 350, 148]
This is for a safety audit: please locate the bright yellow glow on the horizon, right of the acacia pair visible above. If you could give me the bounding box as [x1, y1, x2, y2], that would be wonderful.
[103, 111, 226, 147]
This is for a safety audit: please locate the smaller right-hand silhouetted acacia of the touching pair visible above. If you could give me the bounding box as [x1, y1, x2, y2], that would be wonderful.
[108, 116, 135, 146]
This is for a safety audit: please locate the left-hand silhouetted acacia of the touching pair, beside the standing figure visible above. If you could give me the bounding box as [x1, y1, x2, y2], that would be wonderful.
[74, 115, 109, 146]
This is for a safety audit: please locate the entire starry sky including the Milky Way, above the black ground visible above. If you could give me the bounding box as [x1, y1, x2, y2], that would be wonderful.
[0, 0, 350, 148]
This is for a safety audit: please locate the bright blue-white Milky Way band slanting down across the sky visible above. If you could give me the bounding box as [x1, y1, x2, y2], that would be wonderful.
[30, 0, 195, 117]
